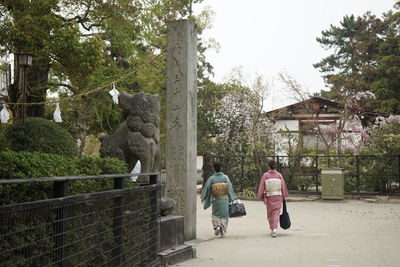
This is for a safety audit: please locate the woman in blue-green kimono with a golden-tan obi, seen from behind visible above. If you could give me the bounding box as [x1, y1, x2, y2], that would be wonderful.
[201, 162, 236, 237]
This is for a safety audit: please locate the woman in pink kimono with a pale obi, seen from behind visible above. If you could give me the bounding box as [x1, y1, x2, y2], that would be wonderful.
[257, 160, 289, 237]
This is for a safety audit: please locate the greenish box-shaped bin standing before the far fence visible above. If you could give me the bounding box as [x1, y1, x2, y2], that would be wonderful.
[321, 168, 344, 199]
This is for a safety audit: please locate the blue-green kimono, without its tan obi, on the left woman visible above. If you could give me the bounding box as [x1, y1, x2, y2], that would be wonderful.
[201, 172, 236, 234]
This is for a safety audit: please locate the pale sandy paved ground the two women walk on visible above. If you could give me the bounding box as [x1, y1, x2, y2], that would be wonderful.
[174, 197, 400, 267]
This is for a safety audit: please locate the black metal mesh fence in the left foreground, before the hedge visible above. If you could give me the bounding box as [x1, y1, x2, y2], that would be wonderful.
[0, 173, 160, 267]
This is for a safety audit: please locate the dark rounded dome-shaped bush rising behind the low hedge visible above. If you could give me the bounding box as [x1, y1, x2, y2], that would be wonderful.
[5, 117, 78, 157]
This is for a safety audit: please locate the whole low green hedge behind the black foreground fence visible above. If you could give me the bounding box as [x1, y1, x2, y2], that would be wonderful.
[0, 151, 145, 266]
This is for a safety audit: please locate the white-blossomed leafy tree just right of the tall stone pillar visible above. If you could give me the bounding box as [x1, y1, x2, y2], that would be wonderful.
[198, 81, 250, 157]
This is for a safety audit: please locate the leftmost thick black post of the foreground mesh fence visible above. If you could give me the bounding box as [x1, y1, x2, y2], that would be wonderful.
[53, 181, 68, 267]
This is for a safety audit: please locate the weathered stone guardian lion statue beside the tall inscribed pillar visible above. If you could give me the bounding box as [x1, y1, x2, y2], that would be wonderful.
[100, 92, 162, 178]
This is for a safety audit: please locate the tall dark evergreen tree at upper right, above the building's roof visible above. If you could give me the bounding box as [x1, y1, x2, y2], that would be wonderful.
[314, 1, 400, 114]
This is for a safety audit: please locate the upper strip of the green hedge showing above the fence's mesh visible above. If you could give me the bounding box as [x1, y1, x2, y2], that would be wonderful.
[0, 151, 131, 205]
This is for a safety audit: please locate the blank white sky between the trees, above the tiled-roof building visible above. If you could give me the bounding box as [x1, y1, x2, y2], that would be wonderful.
[195, 0, 395, 110]
